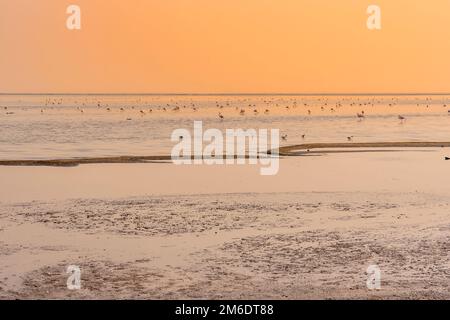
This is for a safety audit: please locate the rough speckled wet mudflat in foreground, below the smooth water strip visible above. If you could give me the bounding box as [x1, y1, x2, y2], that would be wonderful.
[1, 193, 450, 299]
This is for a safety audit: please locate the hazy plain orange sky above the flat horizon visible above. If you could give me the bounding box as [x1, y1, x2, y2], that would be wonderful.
[0, 0, 450, 93]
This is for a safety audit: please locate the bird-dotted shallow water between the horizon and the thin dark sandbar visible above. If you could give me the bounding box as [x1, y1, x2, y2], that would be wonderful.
[0, 95, 450, 160]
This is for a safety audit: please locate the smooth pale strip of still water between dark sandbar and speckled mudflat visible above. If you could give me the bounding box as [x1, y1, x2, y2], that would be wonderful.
[0, 148, 450, 204]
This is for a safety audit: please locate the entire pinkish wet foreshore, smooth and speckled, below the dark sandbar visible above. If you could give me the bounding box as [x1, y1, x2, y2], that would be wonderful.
[0, 151, 450, 299]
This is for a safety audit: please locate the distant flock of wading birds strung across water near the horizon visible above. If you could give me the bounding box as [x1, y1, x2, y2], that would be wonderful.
[0, 97, 450, 160]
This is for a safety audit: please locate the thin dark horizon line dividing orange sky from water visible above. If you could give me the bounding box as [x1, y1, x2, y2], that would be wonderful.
[0, 92, 450, 96]
